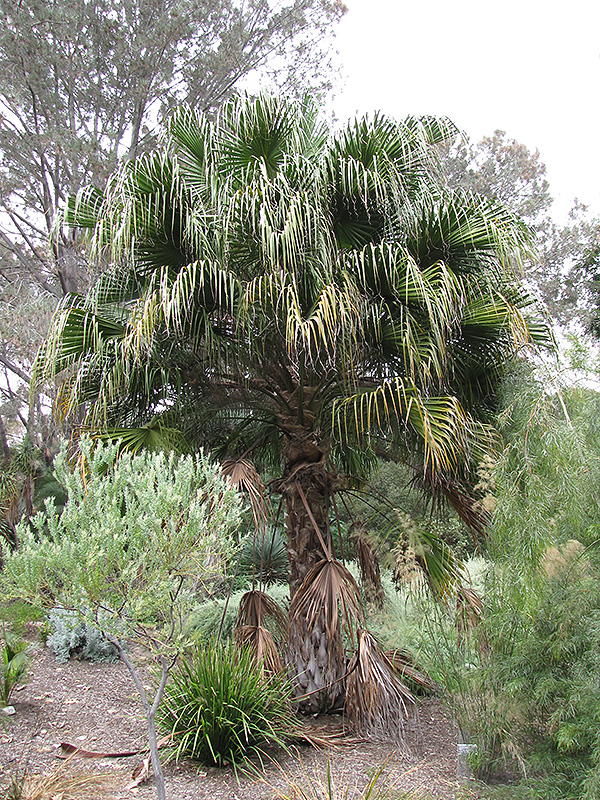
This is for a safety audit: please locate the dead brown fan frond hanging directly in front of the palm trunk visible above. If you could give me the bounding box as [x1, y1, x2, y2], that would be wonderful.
[290, 559, 364, 641]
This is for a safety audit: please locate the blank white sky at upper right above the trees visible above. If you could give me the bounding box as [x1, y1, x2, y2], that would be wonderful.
[334, 0, 600, 219]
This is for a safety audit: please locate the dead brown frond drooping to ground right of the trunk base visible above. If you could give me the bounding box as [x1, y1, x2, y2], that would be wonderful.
[346, 630, 415, 741]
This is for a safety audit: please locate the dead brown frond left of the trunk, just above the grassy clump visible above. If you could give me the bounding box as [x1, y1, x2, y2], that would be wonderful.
[234, 590, 287, 673]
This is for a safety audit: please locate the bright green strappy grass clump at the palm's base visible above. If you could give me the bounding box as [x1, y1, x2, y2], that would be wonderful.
[158, 643, 295, 768]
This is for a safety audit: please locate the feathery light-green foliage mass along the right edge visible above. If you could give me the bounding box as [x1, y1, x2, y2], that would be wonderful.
[414, 365, 600, 800]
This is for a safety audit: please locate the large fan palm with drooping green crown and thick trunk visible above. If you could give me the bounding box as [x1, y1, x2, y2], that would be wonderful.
[37, 96, 545, 710]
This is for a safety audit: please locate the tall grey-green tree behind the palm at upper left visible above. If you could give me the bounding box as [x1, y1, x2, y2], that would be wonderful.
[0, 0, 345, 446]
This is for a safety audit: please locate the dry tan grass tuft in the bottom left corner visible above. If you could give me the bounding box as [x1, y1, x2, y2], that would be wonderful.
[8, 764, 116, 800]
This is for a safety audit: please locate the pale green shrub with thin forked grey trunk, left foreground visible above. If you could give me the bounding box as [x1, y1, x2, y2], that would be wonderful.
[0, 440, 244, 800]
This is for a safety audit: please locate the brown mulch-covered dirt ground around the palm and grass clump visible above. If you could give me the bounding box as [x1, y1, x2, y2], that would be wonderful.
[0, 642, 480, 800]
